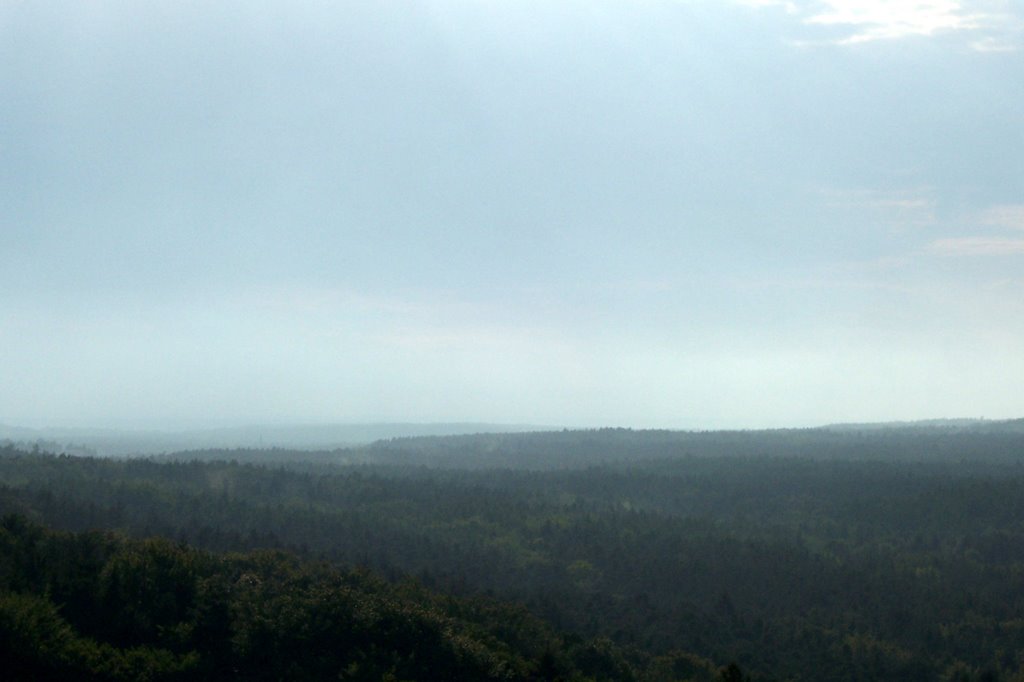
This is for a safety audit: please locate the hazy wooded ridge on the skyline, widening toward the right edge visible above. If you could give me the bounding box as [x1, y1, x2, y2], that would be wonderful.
[146, 421, 1024, 469]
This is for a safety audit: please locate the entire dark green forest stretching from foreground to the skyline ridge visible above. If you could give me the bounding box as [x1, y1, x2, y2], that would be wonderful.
[6, 422, 1024, 681]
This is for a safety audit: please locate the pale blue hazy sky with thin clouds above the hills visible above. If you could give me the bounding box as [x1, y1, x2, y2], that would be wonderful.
[0, 0, 1024, 428]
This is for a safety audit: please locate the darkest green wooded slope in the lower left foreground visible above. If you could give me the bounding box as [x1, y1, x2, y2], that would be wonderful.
[0, 515, 647, 682]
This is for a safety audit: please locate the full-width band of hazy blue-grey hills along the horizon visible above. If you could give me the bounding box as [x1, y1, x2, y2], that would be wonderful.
[0, 419, 1024, 456]
